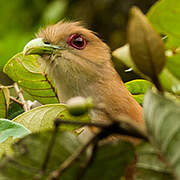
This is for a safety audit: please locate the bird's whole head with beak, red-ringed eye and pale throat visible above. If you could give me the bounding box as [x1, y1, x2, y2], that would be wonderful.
[24, 21, 111, 101]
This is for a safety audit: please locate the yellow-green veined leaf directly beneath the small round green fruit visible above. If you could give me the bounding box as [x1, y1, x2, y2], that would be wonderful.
[0, 104, 89, 156]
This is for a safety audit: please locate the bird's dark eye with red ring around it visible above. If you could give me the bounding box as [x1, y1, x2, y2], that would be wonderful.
[67, 34, 87, 50]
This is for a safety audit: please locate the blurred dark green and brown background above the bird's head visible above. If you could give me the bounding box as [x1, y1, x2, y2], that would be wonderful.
[0, 0, 157, 79]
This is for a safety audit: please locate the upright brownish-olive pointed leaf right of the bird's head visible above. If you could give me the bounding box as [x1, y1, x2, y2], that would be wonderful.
[128, 7, 165, 82]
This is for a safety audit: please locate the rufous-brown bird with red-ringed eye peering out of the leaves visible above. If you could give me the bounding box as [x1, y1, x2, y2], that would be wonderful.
[23, 21, 144, 134]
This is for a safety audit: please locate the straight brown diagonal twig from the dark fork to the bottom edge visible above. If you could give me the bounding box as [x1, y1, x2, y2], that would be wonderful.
[48, 134, 98, 180]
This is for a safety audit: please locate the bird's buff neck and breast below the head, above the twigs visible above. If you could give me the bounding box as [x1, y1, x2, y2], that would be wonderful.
[46, 57, 143, 123]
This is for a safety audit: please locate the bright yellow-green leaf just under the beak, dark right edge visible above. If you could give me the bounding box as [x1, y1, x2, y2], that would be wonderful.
[3, 53, 58, 104]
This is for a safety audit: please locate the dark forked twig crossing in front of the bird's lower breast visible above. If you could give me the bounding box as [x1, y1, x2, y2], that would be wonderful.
[48, 119, 148, 180]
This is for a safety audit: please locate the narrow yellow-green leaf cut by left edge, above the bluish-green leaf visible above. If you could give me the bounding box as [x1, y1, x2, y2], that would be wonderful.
[0, 86, 10, 118]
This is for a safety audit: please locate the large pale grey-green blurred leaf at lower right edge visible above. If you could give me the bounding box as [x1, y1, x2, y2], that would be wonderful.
[144, 91, 180, 179]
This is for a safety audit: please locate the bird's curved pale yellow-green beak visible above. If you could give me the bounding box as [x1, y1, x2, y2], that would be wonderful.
[23, 38, 64, 55]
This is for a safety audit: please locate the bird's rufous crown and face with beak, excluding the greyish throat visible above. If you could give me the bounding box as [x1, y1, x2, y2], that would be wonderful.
[24, 21, 110, 64]
